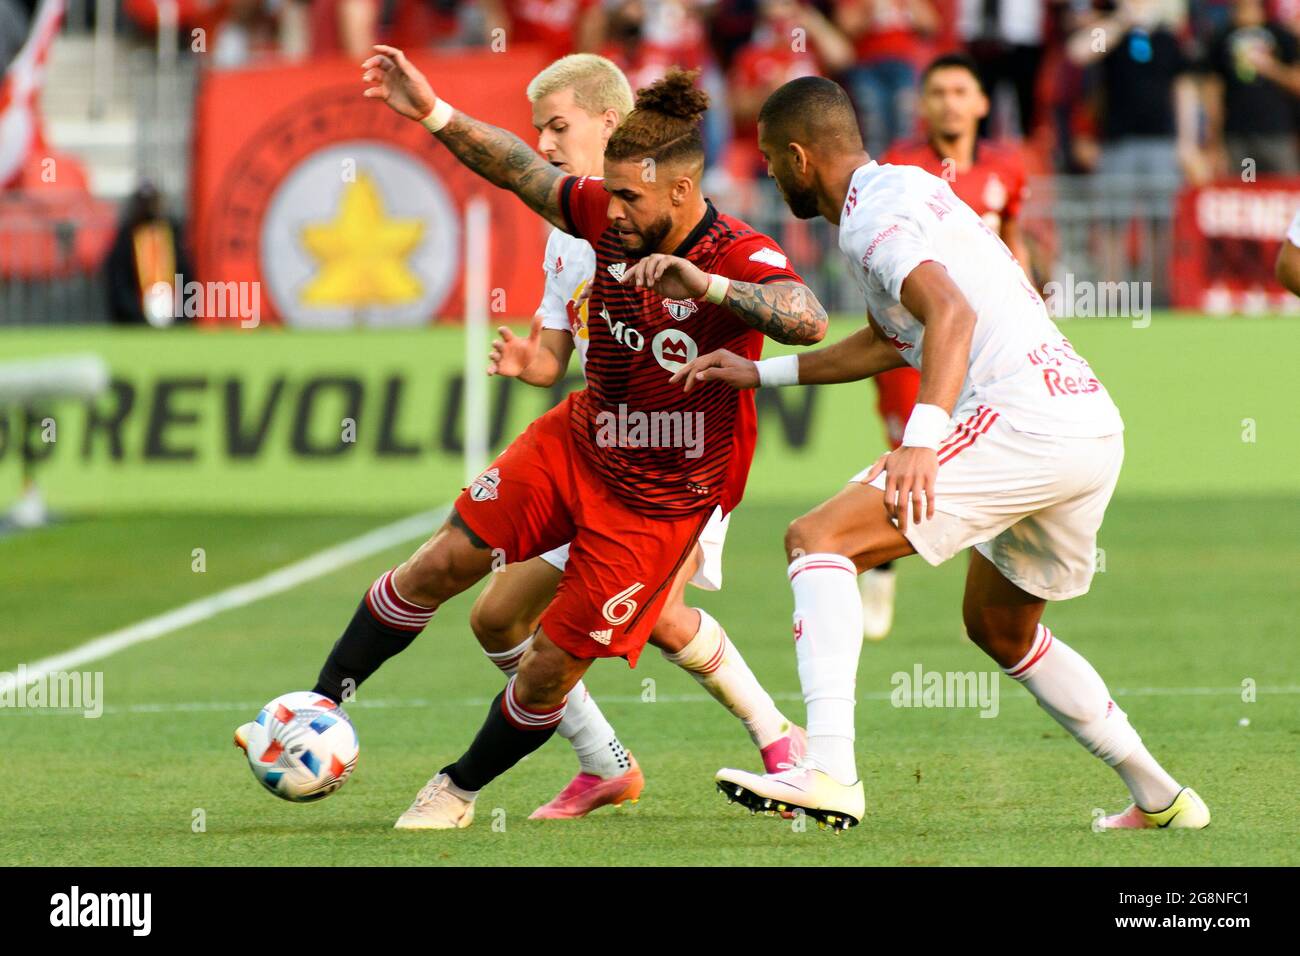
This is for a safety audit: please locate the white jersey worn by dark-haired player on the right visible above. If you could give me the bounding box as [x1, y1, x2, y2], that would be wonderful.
[840, 161, 1123, 438]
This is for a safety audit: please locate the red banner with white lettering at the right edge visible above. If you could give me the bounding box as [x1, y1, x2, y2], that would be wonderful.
[1170, 177, 1300, 315]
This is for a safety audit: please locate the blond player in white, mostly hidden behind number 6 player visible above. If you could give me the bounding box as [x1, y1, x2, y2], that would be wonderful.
[471, 53, 805, 819]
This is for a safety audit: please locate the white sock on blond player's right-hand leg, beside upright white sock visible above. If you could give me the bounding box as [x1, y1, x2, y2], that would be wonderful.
[663, 610, 790, 748]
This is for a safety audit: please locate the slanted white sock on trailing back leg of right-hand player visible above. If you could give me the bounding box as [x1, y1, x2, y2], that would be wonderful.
[1004, 624, 1180, 810]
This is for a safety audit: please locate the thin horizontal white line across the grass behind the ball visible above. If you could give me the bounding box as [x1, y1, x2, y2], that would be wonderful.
[0, 685, 1300, 717]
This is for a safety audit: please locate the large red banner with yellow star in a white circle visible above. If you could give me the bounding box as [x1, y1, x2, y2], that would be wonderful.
[185, 51, 549, 328]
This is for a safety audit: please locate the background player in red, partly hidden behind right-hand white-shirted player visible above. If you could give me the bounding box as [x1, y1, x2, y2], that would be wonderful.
[858, 53, 1034, 640]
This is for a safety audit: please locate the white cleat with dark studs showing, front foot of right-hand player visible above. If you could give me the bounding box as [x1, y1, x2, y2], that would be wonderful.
[714, 767, 867, 832]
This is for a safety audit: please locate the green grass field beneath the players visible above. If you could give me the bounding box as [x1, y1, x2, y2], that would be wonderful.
[0, 316, 1300, 866]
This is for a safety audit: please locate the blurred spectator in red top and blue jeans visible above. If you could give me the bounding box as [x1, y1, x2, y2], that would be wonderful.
[835, 0, 940, 153]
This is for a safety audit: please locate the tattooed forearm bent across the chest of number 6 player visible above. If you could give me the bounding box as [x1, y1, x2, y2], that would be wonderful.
[623, 252, 827, 345]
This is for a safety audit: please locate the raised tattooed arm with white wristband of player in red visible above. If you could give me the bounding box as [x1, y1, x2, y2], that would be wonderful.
[361, 44, 564, 229]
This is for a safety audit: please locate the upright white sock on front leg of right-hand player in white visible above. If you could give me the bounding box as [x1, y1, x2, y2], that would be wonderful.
[788, 554, 862, 784]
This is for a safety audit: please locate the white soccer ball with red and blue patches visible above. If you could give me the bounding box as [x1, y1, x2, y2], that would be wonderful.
[235, 691, 360, 803]
